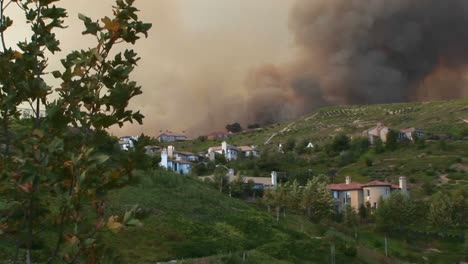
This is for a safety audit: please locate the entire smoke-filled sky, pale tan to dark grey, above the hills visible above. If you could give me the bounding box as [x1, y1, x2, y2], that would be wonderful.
[7, 0, 468, 135]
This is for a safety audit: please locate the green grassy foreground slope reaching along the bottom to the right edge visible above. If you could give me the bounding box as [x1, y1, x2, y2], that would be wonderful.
[88, 171, 464, 264]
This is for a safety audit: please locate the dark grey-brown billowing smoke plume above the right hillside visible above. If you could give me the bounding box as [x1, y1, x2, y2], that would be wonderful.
[247, 0, 468, 125]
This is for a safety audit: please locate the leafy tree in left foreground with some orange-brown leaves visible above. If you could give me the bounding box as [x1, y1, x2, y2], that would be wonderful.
[0, 0, 151, 263]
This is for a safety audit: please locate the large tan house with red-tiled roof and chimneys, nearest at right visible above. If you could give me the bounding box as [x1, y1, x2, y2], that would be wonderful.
[328, 176, 408, 212]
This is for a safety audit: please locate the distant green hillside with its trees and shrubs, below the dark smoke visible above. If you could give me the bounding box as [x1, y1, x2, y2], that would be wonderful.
[172, 99, 468, 193]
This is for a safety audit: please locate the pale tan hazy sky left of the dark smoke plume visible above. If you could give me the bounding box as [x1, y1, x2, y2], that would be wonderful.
[7, 0, 293, 135]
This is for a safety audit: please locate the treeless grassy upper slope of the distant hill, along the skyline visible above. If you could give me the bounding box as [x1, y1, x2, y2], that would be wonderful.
[176, 98, 468, 151]
